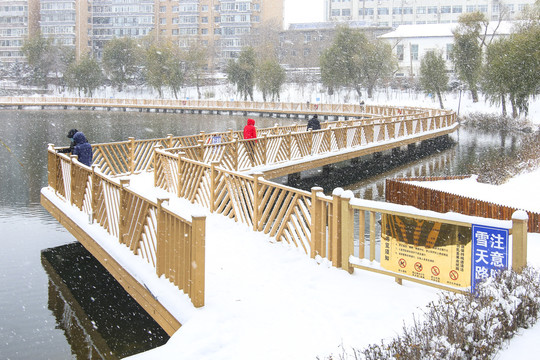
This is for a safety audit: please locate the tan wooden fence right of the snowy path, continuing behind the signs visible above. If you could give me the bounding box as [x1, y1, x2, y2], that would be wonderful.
[154, 149, 526, 291]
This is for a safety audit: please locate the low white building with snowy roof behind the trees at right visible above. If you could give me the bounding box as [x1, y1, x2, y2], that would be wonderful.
[379, 21, 513, 76]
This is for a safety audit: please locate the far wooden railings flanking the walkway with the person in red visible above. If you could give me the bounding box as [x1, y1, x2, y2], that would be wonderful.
[73, 107, 456, 175]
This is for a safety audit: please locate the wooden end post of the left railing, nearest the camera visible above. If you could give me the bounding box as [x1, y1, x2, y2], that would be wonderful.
[189, 216, 206, 307]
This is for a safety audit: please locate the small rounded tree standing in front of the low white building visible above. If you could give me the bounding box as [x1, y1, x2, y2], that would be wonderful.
[420, 50, 448, 109]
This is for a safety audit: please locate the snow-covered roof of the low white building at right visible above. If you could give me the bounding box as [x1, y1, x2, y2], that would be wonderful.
[379, 21, 515, 39]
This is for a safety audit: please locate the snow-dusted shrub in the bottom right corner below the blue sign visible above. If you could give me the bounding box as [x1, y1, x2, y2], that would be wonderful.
[320, 268, 540, 360]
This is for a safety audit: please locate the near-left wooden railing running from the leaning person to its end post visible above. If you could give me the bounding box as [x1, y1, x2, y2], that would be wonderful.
[48, 146, 205, 307]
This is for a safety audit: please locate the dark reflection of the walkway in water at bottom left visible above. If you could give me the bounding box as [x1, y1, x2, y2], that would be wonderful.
[41, 243, 169, 359]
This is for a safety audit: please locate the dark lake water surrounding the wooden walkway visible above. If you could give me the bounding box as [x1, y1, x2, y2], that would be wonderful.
[0, 110, 520, 359]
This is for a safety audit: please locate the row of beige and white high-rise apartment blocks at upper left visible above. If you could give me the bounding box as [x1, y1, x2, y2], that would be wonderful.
[0, 0, 283, 65]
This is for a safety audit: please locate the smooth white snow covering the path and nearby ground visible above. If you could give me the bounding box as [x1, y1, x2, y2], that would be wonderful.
[120, 170, 540, 360]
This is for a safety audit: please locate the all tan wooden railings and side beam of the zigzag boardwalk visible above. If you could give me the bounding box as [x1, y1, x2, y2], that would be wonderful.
[42, 100, 526, 333]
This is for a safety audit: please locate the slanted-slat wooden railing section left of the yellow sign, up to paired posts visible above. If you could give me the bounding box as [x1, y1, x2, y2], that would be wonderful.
[154, 149, 334, 260]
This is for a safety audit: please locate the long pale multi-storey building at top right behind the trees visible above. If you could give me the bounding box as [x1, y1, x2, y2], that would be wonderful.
[325, 0, 535, 28]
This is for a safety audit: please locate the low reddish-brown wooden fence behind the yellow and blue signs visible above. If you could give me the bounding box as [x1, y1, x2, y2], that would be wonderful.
[386, 176, 540, 232]
